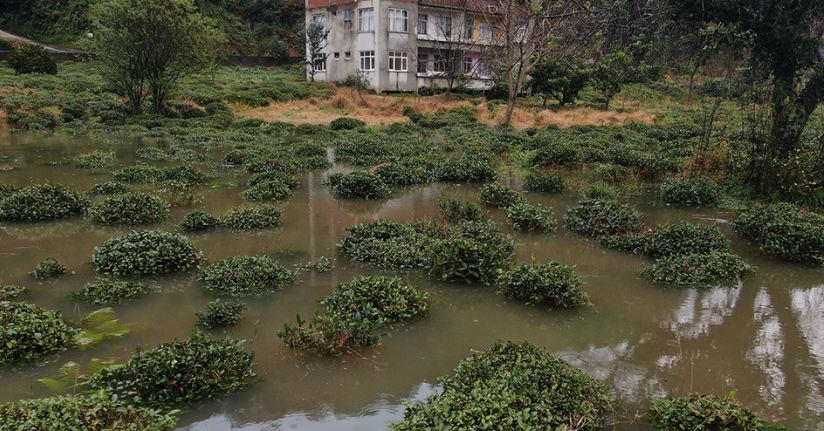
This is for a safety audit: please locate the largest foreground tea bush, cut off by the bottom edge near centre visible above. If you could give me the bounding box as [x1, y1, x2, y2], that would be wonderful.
[392, 341, 613, 431]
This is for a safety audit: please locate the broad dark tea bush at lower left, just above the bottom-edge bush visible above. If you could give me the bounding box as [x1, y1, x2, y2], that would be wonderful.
[88, 332, 255, 409]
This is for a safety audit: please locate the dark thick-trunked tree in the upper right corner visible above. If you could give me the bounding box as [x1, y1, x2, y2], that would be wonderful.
[670, 0, 824, 193]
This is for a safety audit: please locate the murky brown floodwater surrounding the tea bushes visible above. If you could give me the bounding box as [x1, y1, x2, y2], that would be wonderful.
[0, 134, 824, 431]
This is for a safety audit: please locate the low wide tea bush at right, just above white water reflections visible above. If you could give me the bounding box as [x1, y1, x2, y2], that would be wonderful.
[641, 251, 752, 287]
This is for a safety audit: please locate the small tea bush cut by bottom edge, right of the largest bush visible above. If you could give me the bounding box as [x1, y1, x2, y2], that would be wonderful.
[647, 394, 784, 431]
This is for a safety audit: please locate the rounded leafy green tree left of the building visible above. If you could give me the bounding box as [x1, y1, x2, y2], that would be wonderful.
[91, 0, 219, 114]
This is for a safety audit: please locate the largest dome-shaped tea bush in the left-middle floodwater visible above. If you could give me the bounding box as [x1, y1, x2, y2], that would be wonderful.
[92, 231, 201, 276]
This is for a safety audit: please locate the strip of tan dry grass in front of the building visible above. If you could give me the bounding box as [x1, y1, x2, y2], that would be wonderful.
[233, 88, 655, 129]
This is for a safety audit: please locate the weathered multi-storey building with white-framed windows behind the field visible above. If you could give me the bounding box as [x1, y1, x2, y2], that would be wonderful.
[306, 0, 495, 92]
